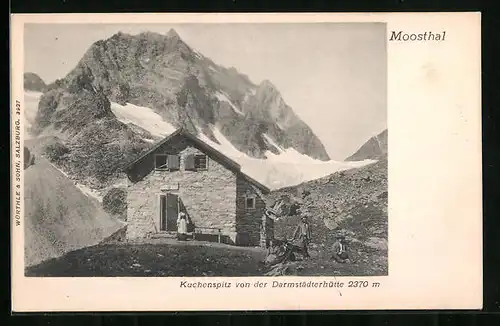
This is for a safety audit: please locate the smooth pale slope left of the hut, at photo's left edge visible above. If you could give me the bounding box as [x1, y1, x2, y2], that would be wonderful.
[24, 151, 122, 266]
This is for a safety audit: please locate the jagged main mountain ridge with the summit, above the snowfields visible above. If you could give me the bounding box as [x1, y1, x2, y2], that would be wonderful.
[40, 30, 329, 161]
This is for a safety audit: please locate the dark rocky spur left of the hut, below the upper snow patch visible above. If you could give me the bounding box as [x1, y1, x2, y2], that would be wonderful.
[32, 80, 150, 189]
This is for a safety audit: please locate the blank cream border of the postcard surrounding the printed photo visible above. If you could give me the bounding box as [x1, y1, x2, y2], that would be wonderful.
[11, 13, 482, 312]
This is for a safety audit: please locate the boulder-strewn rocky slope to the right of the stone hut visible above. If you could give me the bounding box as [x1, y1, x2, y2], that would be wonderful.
[268, 158, 388, 275]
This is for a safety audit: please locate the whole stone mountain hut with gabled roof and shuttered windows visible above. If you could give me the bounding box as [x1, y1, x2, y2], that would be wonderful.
[124, 128, 272, 246]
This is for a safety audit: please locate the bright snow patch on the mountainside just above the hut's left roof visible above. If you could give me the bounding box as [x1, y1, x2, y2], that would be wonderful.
[111, 102, 175, 137]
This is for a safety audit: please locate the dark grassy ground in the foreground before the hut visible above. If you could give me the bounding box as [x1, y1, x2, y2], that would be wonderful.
[26, 244, 263, 277]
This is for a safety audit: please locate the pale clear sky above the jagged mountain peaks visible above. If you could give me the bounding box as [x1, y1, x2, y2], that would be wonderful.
[24, 23, 387, 160]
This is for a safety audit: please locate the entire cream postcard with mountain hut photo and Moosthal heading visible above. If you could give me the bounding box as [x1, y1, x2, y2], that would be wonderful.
[11, 12, 482, 312]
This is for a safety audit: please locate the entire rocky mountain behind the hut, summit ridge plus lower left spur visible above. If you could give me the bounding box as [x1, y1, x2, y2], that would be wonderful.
[31, 30, 329, 186]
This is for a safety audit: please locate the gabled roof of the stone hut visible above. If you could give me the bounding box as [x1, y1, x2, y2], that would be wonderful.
[123, 127, 270, 193]
